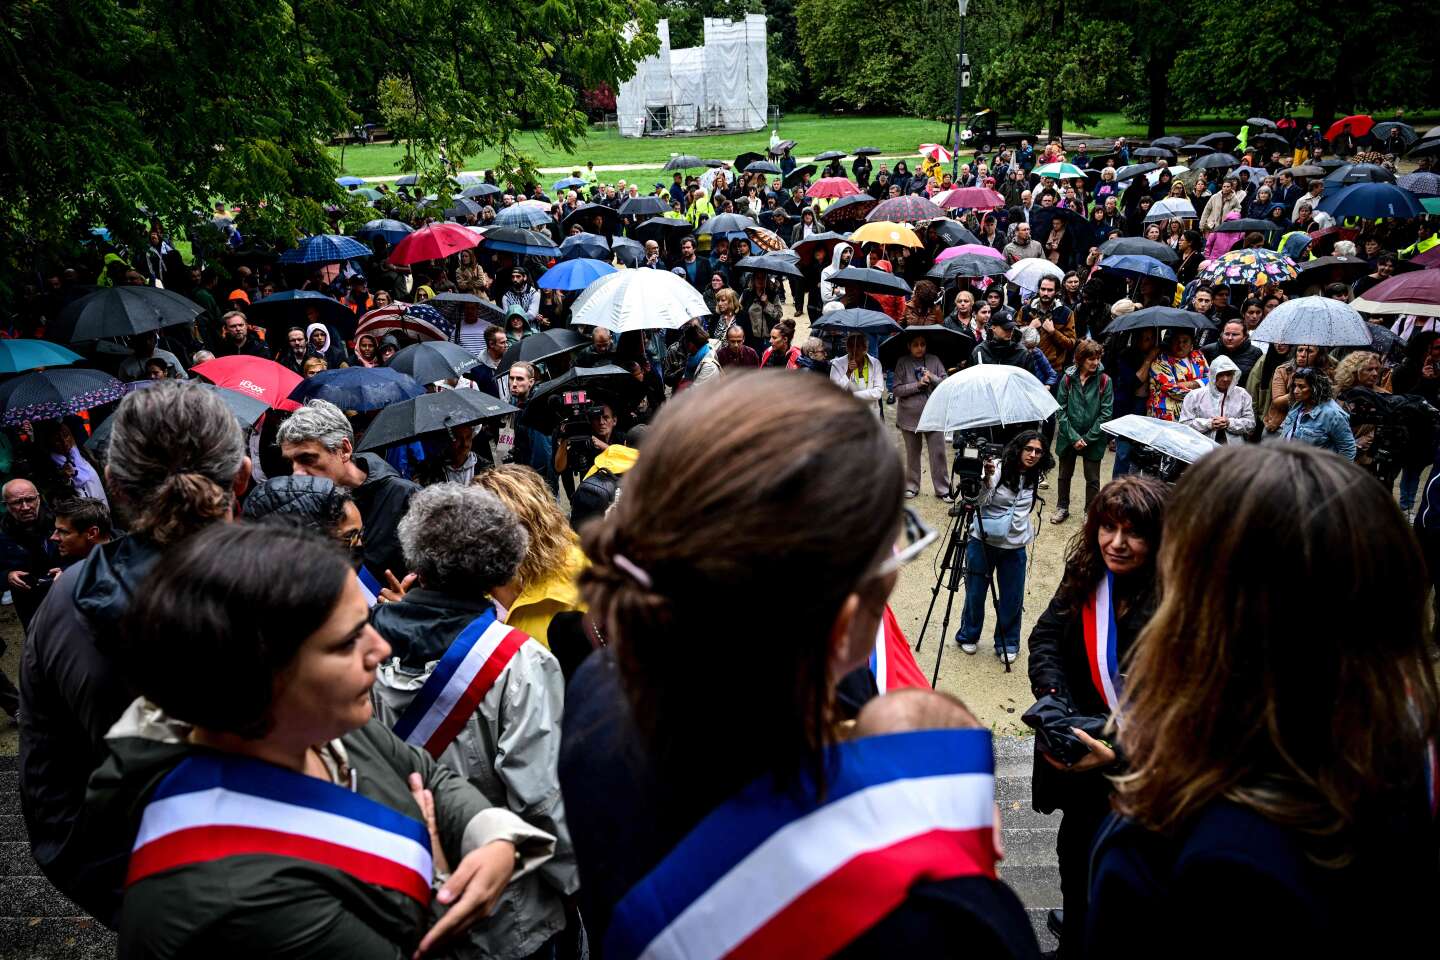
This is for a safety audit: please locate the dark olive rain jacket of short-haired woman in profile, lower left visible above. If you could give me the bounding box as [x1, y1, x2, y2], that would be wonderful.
[85, 698, 554, 960]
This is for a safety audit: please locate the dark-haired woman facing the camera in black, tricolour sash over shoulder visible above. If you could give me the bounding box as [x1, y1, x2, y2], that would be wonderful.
[1030, 475, 1165, 960]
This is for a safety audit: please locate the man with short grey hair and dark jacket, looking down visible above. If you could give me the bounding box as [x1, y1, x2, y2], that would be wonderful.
[275, 400, 419, 584]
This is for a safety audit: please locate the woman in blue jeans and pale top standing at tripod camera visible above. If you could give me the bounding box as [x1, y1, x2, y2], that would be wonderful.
[955, 430, 1056, 664]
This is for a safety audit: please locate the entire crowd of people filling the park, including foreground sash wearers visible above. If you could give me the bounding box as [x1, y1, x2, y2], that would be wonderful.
[0, 120, 1440, 959]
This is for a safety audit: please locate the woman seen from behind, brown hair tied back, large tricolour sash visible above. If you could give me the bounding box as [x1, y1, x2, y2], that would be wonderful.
[560, 371, 1037, 960]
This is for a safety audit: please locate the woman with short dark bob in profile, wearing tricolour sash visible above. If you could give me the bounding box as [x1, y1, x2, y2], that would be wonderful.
[82, 525, 554, 960]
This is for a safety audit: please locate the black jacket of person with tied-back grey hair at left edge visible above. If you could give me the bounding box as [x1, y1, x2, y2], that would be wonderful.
[20, 537, 160, 927]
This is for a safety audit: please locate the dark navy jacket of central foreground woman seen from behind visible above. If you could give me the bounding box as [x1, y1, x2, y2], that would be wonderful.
[560, 649, 1038, 959]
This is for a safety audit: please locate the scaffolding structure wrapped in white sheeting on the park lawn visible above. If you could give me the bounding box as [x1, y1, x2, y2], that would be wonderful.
[615, 13, 770, 137]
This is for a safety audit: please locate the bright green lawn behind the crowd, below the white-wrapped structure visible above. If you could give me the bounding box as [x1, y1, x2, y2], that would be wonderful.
[330, 114, 945, 183]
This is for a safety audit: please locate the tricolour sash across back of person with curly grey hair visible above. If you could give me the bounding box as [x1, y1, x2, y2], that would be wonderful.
[395, 609, 530, 757]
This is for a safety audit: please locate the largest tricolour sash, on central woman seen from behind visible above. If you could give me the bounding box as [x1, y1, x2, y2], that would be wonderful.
[605, 730, 995, 960]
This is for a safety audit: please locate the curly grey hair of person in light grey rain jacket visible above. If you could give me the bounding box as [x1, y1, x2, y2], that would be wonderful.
[399, 484, 530, 594]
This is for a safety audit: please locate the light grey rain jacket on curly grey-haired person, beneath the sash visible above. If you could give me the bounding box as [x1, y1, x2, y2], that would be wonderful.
[372, 587, 579, 957]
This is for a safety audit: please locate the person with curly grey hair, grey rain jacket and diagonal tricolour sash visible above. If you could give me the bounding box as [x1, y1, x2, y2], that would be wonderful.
[372, 484, 579, 957]
